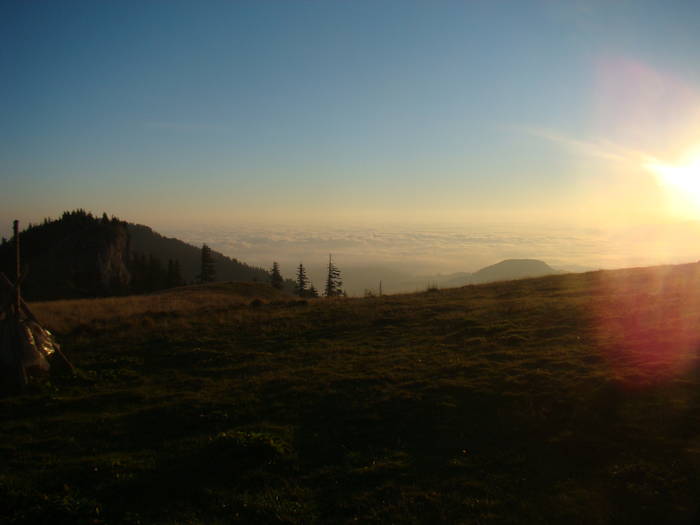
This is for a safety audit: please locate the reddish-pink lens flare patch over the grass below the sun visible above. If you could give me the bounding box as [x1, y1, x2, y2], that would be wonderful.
[591, 264, 700, 388]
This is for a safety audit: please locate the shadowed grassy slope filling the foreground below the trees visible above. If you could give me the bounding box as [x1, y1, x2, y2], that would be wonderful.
[0, 265, 700, 524]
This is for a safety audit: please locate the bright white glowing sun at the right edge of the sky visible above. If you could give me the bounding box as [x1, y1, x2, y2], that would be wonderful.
[644, 149, 700, 218]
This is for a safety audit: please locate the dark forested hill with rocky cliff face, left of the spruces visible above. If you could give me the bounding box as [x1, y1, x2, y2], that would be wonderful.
[0, 210, 292, 300]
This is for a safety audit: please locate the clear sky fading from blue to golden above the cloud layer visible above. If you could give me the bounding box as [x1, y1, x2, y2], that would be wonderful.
[0, 0, 700, 274]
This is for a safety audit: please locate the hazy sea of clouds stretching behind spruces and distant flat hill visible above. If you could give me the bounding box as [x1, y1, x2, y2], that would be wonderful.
[161, 223, 700, 294]
